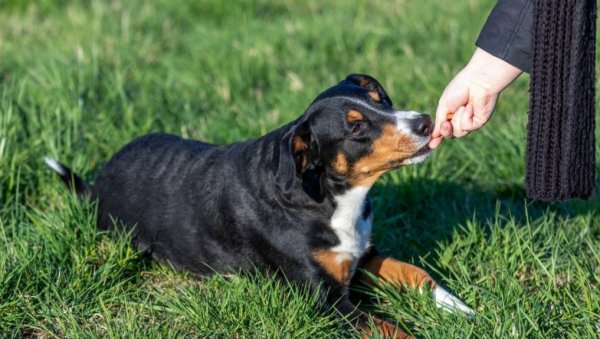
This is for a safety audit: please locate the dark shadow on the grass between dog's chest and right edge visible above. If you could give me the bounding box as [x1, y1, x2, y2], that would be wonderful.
[370, 175, 600, 262]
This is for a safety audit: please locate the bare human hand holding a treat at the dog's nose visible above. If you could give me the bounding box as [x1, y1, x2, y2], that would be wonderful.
[429, 48, 523, 149]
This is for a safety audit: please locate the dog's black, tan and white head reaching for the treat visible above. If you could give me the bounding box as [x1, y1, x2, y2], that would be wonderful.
[276, 74, 433, 197]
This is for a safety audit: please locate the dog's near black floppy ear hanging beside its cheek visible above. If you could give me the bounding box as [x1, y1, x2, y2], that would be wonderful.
[275, 120, 320, 193]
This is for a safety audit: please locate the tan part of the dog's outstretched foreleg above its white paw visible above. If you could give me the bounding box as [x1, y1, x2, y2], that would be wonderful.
[361, 256, 436, 289]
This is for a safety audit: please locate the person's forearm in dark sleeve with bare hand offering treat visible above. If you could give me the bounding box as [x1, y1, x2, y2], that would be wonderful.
[429, 0, 533, 148]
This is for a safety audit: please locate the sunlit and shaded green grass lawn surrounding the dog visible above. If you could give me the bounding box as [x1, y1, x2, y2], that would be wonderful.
[0, 0, 600, 338]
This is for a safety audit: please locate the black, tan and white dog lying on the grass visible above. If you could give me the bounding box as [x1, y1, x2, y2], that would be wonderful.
[46, 74, 473, 338]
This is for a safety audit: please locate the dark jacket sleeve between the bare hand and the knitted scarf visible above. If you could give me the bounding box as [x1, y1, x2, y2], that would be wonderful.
[475, 0, 533, 72]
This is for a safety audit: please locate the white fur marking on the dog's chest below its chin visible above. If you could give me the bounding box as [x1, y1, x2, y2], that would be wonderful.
[331, 186, 373, 266]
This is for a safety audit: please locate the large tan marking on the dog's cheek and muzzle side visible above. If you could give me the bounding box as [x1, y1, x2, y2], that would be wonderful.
[350, 124, 417, 186]
